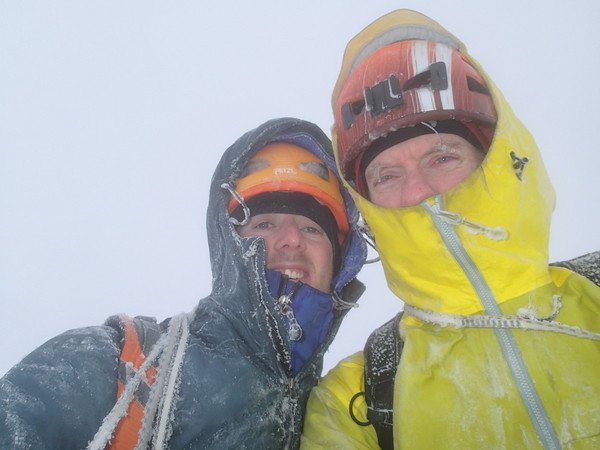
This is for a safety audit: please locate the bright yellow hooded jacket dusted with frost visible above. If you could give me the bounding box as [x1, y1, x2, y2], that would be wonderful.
[302, 11, 600, 449]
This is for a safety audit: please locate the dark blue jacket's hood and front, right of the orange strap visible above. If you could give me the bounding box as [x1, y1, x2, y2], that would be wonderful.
[177, 118, 367, 448]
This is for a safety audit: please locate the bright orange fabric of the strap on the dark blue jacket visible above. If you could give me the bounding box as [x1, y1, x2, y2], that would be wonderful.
[106, 315, 156, 450]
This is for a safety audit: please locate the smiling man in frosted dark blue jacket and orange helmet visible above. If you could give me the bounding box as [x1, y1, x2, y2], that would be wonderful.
[0, 118, 366, 449]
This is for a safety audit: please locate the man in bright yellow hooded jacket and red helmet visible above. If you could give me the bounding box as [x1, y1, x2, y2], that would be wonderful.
[302, 10, 600, 449]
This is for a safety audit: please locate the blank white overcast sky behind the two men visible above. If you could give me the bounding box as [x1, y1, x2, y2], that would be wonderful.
[0, 0, 600, 375]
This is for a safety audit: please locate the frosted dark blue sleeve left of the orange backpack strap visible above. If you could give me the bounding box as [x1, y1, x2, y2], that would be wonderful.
[0, 326, 120, 449]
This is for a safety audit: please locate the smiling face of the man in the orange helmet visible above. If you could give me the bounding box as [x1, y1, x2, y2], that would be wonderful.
[238, 213, 333, 292]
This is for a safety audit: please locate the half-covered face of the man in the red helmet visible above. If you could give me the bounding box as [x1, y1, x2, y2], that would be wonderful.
[365, 133, 485, 208]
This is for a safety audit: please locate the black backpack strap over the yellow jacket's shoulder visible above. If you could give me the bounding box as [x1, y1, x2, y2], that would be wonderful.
[364, 313, 404, 449]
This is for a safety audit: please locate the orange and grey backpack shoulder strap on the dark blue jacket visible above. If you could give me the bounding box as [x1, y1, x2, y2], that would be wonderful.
[106, 314, 162, 449]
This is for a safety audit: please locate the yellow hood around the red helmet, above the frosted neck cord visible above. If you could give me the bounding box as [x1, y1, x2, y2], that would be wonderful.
[332, 10, 555, 314]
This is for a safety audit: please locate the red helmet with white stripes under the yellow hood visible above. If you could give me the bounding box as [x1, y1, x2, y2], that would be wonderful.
[334, 40, 497, 183]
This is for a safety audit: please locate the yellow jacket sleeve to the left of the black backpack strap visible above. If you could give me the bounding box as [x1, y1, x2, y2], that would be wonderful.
[300, 352, 379, 449]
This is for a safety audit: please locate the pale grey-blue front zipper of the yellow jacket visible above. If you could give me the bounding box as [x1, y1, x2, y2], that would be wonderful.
[422, 195, 561, 449]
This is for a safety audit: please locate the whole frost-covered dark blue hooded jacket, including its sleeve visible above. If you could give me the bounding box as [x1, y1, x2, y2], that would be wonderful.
[0, 118, 366, 449]
